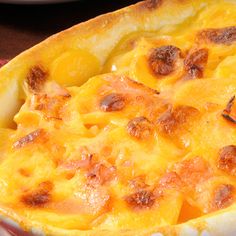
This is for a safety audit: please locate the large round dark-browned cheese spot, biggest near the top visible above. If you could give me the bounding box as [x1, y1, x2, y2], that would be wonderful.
[148, 45, 181, 76]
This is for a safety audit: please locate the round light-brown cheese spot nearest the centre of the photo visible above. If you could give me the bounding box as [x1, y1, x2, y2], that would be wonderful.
[127, 116, 155, 140]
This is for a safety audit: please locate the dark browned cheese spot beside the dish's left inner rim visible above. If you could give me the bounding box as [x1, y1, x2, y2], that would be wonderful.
[26, 65, 48, 92]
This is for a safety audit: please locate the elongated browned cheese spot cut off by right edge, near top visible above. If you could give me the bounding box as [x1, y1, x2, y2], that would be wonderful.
[197, 26, 236, 44]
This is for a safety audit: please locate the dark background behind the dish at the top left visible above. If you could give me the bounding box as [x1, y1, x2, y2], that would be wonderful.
[0, 0, 140, 59]
